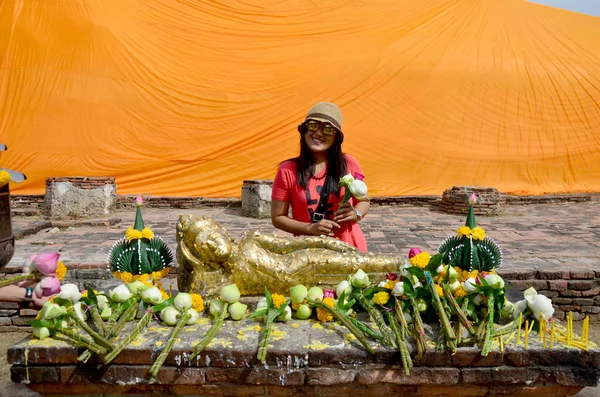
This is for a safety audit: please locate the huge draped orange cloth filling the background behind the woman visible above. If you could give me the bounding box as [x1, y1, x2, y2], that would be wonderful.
[0, 0, 600, 197]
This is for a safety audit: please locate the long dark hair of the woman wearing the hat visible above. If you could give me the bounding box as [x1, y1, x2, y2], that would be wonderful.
[293, 130, 346, 195]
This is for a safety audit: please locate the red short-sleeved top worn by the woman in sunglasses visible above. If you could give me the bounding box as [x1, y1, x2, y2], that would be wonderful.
[271, 154, 367, 252]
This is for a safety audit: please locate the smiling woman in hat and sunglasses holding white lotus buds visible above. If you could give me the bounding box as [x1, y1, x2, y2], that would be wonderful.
[271, 102, 370, 252]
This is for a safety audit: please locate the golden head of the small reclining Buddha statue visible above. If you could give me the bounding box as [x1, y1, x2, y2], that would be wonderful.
[177, 215, 233, 264]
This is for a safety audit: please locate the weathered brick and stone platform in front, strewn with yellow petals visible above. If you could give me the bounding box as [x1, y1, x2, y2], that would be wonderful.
[8, 319, 600, 397]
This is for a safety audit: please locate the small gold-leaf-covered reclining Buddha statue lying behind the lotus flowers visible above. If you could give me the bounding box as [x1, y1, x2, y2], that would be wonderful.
[177, 215, 403, 295]
